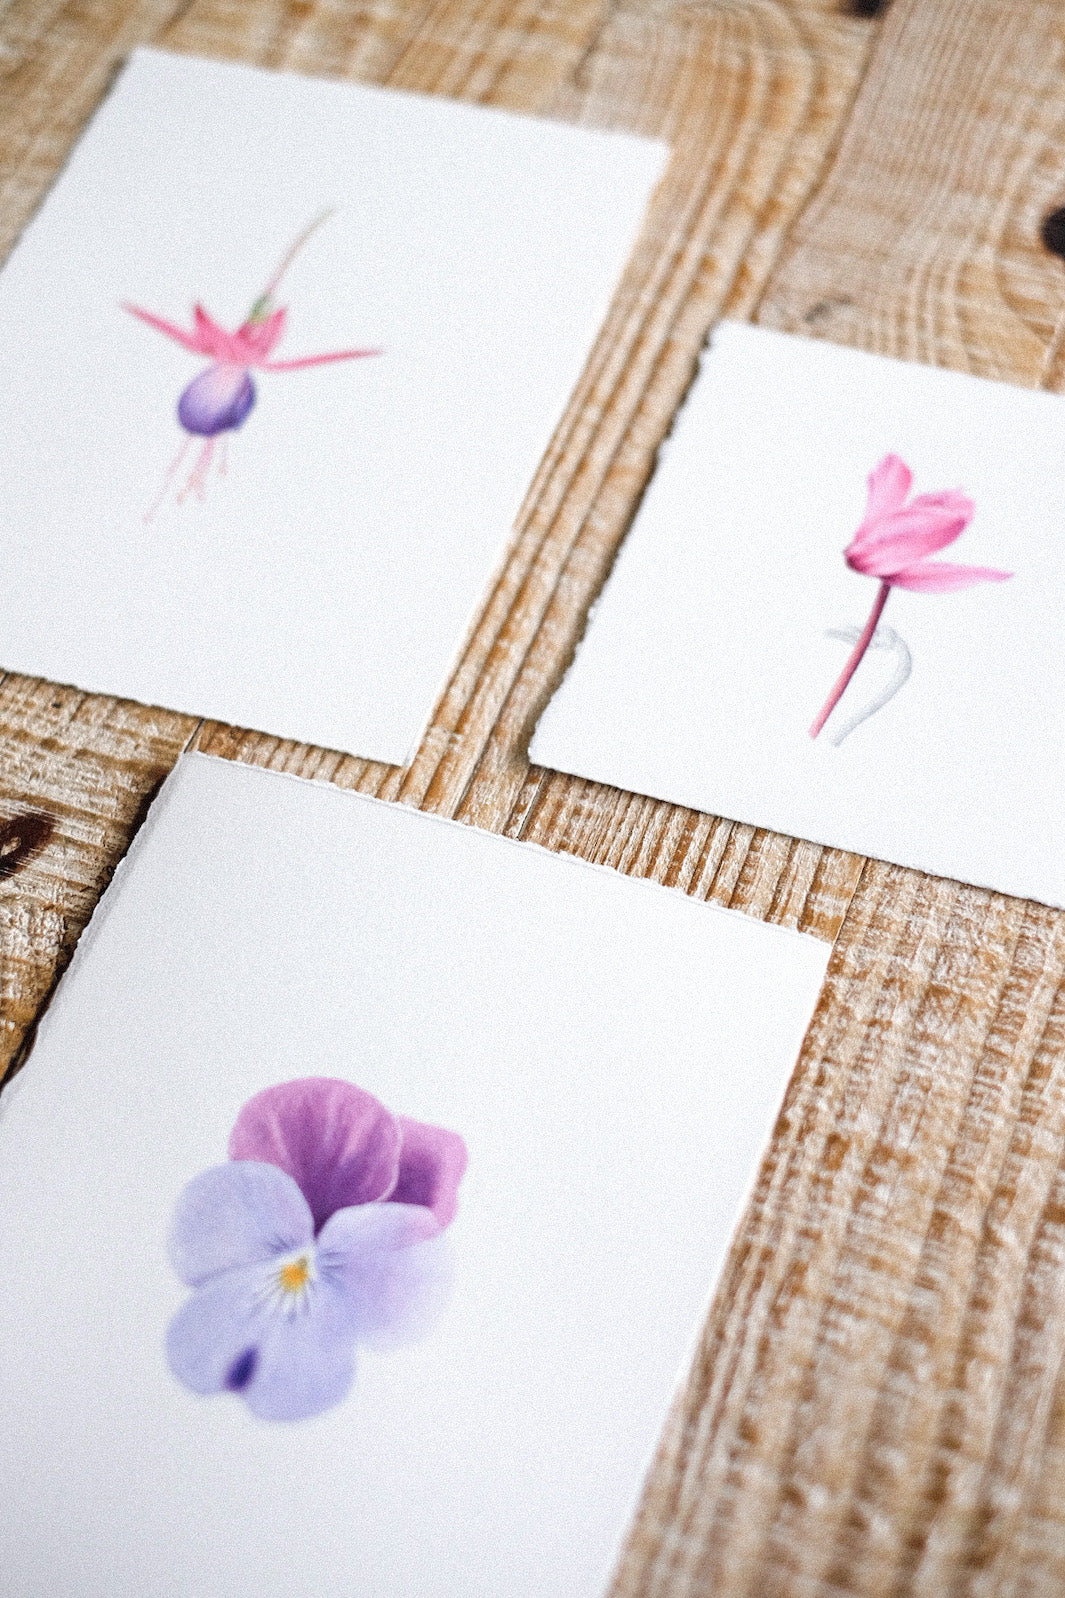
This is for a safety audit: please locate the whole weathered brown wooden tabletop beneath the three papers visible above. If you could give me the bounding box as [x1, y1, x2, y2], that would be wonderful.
[0, 0, 1065, 1598]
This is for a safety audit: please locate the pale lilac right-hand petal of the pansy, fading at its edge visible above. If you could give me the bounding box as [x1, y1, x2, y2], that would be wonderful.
[318, 1203, 451, 1349]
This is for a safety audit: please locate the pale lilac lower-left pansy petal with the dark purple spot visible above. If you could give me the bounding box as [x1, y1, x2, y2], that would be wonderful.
[166, 1264, 270, 1393]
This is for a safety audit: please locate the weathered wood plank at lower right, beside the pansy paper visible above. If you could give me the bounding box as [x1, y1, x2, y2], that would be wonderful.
[617, 865, 1065, 1598]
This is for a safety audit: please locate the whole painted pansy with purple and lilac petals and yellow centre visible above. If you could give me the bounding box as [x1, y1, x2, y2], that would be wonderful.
[166, 1077, 467, 1421]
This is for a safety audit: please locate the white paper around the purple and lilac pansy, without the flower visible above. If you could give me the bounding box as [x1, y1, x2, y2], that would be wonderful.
[0, 756, 827, 1598]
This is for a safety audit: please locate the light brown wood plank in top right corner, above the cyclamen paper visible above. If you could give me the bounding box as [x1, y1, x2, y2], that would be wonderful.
[756, 0, 1065, 387]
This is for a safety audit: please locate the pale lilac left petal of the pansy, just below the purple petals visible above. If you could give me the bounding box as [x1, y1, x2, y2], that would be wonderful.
[170, 1160, 313, 1286]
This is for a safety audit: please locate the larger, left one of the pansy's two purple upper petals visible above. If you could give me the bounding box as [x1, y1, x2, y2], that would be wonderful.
[229, 1077, 400, 1230]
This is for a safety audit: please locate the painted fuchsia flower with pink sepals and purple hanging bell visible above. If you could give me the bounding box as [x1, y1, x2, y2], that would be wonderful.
[123, 211, 382, 521]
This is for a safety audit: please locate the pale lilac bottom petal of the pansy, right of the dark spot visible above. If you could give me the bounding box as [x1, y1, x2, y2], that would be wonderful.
[241, 1280, 355, 1421]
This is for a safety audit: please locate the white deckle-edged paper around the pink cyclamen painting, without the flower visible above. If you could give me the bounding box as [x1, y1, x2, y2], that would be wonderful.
[531, 323, 1065, 904]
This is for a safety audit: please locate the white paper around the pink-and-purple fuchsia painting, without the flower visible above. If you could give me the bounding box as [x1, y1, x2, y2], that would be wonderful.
[0, 51, 665, 762]
